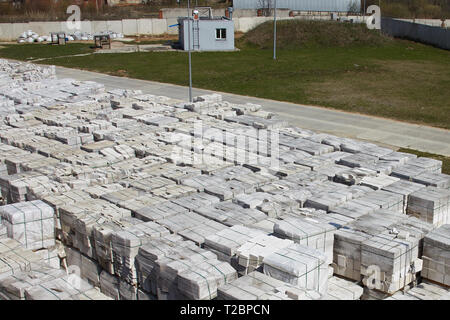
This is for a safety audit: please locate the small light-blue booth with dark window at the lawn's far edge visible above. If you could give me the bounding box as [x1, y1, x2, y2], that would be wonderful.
[178, 7, 234, 51]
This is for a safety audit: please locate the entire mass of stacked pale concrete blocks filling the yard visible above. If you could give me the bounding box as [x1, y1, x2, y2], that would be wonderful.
[0, 60, 450, 300]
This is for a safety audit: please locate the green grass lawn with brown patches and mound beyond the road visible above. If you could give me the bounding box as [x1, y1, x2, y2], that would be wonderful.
[0, 23, 450, 129]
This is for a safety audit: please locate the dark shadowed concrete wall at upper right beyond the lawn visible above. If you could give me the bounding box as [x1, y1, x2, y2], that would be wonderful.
[381, 18, 450, 50]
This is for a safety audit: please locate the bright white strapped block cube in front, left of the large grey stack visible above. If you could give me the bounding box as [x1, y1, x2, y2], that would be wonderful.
[264, 243, 328, 294]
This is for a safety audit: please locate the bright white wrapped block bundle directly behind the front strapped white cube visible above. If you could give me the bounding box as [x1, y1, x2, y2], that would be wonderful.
[274, 217, 336, 264]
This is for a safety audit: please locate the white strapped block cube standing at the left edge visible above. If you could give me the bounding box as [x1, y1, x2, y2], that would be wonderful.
[0, 200, 55, 250]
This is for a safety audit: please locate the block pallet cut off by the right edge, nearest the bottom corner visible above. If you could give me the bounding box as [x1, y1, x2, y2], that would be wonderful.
[421, 224, 450, 287]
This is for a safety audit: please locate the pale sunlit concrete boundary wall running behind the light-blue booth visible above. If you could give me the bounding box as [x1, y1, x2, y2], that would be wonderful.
[0, 15, 361, 41]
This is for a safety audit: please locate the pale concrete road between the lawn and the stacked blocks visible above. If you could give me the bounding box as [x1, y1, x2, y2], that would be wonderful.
[56, 67, 450, 156]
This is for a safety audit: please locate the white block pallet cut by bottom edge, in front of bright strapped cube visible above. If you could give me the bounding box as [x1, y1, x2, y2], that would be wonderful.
[217, 271, 322, 300]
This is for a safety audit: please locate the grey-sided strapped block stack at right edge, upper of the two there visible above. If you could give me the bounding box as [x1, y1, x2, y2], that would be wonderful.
[406, 187, 450, 227]
